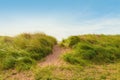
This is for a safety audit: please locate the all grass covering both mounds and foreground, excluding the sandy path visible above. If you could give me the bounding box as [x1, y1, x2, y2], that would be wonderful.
[0, 33, 120, 80]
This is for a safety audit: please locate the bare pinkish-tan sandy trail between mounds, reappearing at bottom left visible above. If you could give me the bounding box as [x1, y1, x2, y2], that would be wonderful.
[5, 45, 69, 80]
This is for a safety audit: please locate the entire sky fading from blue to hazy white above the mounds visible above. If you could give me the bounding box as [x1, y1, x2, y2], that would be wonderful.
[0, 0, 120, 40]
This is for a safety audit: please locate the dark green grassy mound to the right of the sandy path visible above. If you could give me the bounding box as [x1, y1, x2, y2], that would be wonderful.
[61, 35, 120, 65]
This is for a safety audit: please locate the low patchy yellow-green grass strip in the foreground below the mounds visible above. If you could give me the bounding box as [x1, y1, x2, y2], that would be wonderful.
[0, 62, 120, 80]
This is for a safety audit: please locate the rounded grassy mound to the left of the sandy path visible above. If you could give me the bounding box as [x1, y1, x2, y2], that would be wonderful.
[0, 33, 56, 71]
